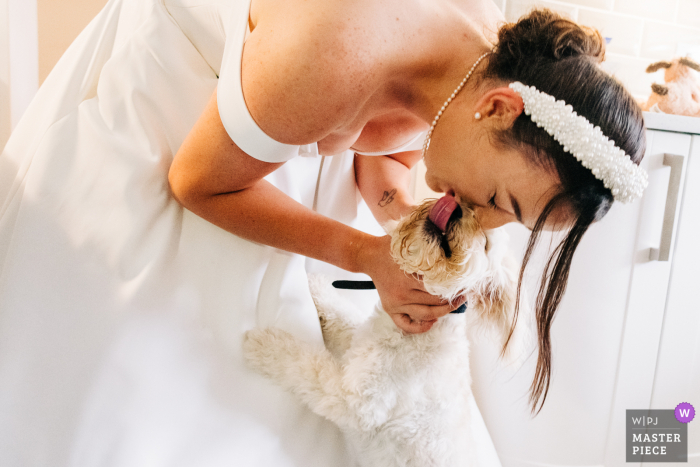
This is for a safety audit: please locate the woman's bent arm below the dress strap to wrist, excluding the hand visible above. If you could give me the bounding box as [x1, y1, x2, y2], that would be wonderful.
[169, 92, 360, 272]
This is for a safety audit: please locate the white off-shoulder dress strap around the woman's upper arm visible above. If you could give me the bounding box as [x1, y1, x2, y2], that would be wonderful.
[217, 0, 299, 163]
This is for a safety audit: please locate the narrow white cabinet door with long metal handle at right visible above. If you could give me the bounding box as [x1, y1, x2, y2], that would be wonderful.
[604, 131, 691, 467]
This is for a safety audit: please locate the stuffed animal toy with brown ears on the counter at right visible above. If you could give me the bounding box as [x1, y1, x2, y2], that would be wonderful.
[642, 57, 700, 117]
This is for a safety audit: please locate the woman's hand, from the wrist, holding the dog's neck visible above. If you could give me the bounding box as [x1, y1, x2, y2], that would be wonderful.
[358, 236, 465, 334]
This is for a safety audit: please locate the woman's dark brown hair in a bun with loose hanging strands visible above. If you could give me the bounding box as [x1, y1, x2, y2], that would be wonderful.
[481, 9, 646, 413]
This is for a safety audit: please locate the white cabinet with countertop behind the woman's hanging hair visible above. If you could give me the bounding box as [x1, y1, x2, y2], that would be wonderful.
[464, 114, 700, 467]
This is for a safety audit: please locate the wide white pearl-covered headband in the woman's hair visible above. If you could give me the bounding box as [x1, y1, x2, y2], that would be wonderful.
[509, 81, 648, 203]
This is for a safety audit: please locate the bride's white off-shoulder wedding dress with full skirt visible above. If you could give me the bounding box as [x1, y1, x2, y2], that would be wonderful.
[0, 0, 500, 467]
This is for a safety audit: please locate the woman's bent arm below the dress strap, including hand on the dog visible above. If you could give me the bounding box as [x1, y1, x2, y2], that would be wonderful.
[169, 93, 453, 333]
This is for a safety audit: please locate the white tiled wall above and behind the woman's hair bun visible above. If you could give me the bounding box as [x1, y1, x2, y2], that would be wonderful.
[494, 0, 700, 99]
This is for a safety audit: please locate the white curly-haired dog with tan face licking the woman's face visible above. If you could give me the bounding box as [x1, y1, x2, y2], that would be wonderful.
[244, 200, 529, 467]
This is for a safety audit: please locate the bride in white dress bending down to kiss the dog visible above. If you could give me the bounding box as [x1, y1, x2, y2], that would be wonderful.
[0, 0, 644, 466]
